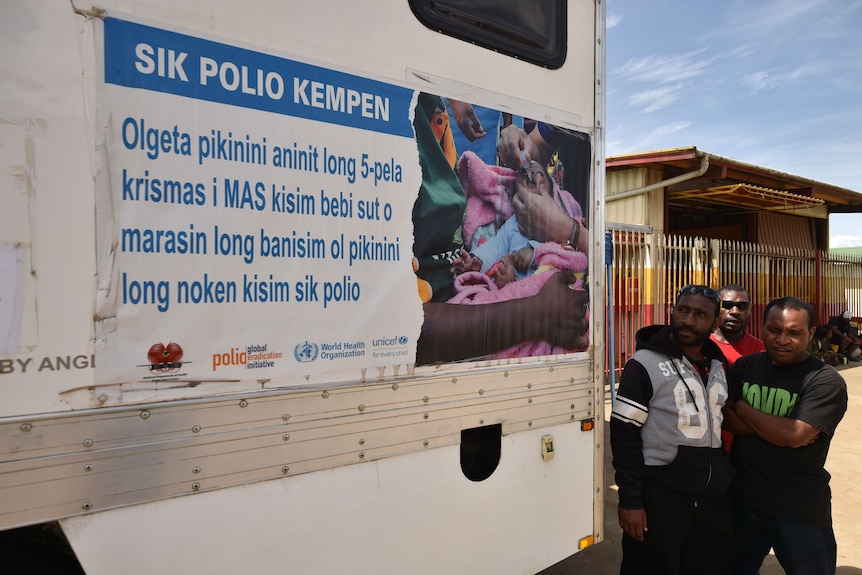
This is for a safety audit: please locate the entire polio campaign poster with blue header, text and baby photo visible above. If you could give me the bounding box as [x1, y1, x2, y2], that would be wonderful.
[96, 18, 591, 384]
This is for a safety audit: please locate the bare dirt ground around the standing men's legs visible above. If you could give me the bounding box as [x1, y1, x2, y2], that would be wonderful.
[540, 363, 862, 575]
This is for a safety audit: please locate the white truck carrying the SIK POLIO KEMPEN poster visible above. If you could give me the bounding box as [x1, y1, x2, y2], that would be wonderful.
[0, 0, 605, 574]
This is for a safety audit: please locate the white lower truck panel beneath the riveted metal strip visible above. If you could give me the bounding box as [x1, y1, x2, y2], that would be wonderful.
[63, 425, 593, 575]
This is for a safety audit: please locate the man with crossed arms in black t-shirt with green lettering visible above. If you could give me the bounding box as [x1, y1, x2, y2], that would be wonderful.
[724, 298, 847, 575]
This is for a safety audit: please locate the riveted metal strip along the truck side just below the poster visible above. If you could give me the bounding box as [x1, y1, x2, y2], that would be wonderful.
[0, 367, 596, 526]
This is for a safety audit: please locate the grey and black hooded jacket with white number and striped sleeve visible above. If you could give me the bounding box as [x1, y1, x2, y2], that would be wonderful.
[610, 325, 733, 509]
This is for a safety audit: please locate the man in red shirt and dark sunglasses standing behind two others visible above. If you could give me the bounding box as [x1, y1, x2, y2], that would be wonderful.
[711, 284, 766, 365]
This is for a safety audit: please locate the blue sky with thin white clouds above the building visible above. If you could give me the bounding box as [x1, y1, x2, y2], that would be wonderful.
[605, 0, 862, 248]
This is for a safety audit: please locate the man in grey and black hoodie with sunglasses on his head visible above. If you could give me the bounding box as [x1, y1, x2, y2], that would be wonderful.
[610, 285, 733, 575]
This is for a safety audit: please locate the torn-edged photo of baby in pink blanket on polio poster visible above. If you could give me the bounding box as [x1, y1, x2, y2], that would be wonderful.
[413, 93, 591, 365]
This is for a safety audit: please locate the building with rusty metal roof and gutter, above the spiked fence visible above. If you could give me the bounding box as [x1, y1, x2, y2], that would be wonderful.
[605, 146, 862, 250]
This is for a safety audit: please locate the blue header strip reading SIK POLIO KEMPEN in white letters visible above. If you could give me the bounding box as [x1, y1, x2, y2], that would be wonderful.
[105, 18, 413, 138]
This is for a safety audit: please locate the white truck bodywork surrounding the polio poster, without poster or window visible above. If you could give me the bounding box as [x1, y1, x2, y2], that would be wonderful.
[0, 0, 605, 574]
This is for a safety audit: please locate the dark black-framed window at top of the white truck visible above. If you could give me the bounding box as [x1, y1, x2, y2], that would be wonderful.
[408, 0, 566, 69]
